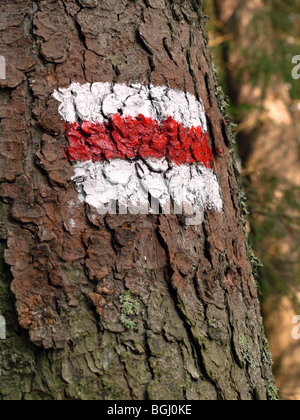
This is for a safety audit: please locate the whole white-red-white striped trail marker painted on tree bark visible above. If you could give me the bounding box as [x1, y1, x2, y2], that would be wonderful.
[54, 83, 222, 225]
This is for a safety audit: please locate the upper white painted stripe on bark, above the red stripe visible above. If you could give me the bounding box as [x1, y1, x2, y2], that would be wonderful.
[54, 83, 207, 132]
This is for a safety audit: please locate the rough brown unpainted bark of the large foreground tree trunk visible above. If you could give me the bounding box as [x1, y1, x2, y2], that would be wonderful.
[0, 0, 276, 400]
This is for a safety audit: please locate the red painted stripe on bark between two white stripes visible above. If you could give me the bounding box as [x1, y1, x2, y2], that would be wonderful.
[65, 114, 214, 168]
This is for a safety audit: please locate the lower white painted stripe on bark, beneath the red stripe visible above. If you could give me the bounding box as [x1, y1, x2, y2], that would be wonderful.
[73, 158, 222, 224]
